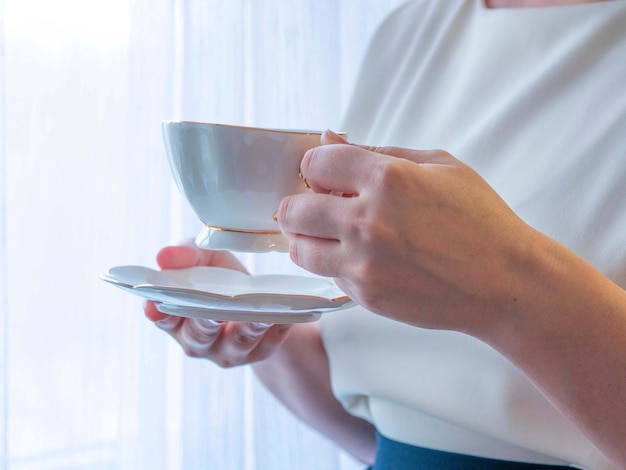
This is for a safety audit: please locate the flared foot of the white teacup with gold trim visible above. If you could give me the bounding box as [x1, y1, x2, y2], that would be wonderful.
[196, 227, 289, 253]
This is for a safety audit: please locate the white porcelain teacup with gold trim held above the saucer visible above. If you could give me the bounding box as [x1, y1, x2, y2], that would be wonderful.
[162, 121, 336, 253]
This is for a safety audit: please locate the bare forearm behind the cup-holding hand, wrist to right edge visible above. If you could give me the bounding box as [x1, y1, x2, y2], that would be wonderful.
[477, 233, 626, 468]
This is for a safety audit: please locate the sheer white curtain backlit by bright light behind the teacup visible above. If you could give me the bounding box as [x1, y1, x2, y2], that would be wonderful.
[0, 0, 401, 470]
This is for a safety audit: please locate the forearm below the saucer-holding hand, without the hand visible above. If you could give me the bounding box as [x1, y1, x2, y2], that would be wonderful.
[253, 323, 376, 464]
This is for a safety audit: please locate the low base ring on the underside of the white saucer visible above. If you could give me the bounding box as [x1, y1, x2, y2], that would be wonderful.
[156, 303, 322, 324]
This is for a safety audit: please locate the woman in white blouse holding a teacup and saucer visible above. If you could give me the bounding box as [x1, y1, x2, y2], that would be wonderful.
[146, 0, 626, 470]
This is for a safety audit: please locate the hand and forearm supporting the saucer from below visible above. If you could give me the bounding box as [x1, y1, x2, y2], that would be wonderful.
[145, 241, 376, 464]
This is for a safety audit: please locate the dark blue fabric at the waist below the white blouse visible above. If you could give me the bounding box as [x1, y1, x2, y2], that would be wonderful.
[369, 434, 571, 470]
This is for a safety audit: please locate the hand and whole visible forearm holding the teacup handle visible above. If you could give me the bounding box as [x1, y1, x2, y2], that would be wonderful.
[278, 133, 626, 468]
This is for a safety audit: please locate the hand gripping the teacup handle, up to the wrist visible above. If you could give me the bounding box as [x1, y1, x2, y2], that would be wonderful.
[278, 131, 540, 332]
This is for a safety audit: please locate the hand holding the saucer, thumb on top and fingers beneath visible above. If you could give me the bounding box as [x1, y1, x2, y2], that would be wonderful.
[144, 242, 291, 367]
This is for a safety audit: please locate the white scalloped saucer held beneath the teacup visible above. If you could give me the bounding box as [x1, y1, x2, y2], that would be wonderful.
[100, 266, 353, 321]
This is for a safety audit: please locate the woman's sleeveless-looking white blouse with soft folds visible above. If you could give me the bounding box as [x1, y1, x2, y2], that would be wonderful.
[321, 0, 626, 470]
